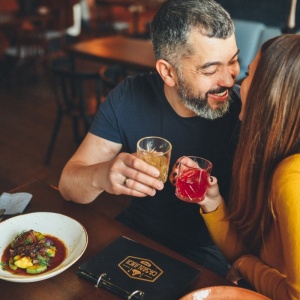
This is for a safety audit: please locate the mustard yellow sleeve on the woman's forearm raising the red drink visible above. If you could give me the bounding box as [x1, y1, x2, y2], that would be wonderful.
[200, 201, 246, 263]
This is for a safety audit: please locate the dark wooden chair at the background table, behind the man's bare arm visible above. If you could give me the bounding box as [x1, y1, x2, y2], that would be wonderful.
[44, 58, 102, 164]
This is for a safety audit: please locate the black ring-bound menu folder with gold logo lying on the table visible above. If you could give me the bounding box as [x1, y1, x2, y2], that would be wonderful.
[77, 236, 201, 300]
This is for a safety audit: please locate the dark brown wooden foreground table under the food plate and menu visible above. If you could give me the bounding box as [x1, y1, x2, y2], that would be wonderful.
[0, 182, 232, 300]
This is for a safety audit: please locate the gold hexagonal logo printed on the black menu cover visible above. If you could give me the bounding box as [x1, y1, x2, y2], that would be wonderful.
[118, 256, 163, 282]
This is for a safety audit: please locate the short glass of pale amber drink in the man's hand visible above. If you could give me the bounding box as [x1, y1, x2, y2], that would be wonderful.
[137, 136, 172, 183]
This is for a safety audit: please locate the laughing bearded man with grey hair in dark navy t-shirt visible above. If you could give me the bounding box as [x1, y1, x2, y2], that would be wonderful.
[59, 0, 241, 275]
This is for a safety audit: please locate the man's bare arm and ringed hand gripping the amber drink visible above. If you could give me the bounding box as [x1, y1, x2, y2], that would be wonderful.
[59, 133, 163, 203]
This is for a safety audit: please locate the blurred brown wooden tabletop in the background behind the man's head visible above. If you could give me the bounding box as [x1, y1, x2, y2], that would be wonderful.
[67, 36, 155, 71]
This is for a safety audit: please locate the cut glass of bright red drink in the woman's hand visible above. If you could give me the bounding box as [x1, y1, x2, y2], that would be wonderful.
[175, 156, 212, 203]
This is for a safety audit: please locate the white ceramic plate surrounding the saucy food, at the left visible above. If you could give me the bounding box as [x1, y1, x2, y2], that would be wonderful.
[0, 212, 88, 282]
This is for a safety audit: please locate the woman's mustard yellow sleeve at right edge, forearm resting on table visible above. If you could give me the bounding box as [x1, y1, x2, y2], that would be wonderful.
[240, 155, 300, 300]
